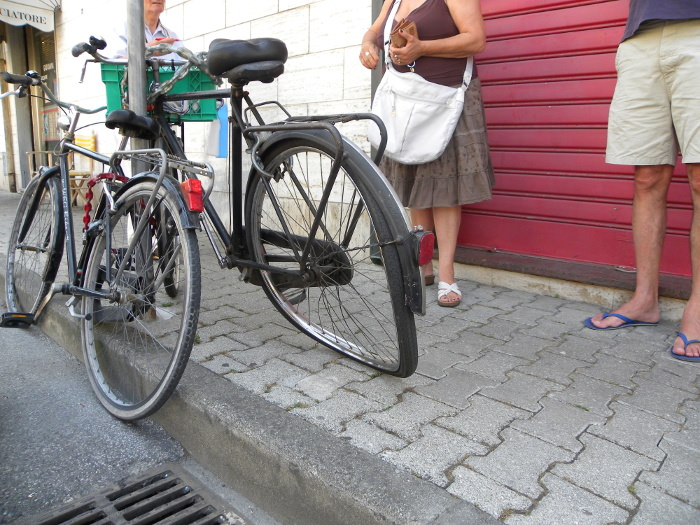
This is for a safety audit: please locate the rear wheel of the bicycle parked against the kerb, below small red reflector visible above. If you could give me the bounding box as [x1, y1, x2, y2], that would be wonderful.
[81, 179, 201, 420]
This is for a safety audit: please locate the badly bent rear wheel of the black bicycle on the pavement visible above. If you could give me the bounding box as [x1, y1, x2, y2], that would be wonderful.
[246, 134, 418, 377]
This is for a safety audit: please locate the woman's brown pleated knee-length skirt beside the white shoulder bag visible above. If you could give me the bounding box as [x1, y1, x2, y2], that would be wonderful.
[379, 77, 495, 209]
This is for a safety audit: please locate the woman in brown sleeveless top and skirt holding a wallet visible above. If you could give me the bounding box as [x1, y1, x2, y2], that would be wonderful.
[360, 0, 494, 306]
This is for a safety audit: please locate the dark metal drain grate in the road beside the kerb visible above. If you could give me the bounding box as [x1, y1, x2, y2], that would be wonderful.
[18, 468, 245, 525]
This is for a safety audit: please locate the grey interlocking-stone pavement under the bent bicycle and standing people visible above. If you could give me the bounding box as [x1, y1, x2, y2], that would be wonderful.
[0, 192, 700, 525]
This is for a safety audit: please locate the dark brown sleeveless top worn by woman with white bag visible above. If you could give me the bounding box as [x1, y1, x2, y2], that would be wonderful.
[375, 0, 476, 86]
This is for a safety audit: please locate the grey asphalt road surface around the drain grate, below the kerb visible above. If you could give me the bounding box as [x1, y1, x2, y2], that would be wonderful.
[0, 322, 274, 525]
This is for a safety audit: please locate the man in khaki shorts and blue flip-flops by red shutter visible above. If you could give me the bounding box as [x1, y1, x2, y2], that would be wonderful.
[585, 0, 700, 361]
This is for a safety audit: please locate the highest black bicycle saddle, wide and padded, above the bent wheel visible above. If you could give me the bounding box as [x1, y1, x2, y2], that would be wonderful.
[207, 38, 288, 85]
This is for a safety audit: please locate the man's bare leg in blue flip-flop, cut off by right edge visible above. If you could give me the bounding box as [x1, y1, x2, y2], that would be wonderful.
[673, 164, 700, 357]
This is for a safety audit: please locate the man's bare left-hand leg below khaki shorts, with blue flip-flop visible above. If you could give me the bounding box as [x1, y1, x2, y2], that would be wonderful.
[591, 165, 676, 328]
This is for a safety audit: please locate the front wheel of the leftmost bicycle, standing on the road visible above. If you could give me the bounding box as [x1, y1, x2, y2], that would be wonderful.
[5, 170, 65, 314]
